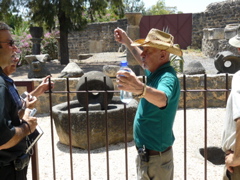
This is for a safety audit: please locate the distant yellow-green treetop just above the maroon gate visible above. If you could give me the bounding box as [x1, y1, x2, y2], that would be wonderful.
[147, 0, 177, 15]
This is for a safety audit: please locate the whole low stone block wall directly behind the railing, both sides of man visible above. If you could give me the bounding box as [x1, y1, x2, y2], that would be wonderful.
[18, 74, 232, 114]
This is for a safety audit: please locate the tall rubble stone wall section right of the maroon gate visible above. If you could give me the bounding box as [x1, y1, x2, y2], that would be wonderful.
[191, 1, 240, 49]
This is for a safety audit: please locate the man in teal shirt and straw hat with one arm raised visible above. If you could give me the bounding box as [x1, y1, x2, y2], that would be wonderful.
[114, 28, 182, 180]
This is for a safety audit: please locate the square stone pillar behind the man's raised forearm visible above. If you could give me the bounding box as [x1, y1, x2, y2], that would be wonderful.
[125, 13, 142, 75]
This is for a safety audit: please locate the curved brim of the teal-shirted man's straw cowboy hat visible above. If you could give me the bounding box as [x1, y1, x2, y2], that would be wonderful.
[131, 39, 183, 56]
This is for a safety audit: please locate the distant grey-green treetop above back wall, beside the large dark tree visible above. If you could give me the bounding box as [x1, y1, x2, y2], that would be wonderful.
[123, 0, 146, 14]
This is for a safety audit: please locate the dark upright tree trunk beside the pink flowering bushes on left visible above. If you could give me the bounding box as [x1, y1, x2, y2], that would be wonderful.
[59, 13, 69, 65]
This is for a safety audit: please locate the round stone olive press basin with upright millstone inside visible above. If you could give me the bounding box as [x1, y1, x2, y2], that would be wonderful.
[53, 71, 138, 149]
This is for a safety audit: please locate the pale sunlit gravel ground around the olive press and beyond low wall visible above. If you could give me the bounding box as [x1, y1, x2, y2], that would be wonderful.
[12, 51, 225, 180]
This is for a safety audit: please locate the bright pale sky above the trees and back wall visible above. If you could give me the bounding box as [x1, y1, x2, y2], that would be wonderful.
[143, 0, 223, 13]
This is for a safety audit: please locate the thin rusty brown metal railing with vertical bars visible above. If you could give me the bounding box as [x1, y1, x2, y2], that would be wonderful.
[16, 74, 230, 180]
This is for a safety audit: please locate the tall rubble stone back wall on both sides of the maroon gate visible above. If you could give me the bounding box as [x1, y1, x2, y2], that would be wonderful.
[68, 0, 240, 59]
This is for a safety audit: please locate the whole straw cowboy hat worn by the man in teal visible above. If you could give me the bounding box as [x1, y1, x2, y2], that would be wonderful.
[131, 28, 182, 56]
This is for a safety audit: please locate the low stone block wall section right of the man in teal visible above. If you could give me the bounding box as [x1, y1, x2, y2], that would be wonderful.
[179, 74, 232, 108]
